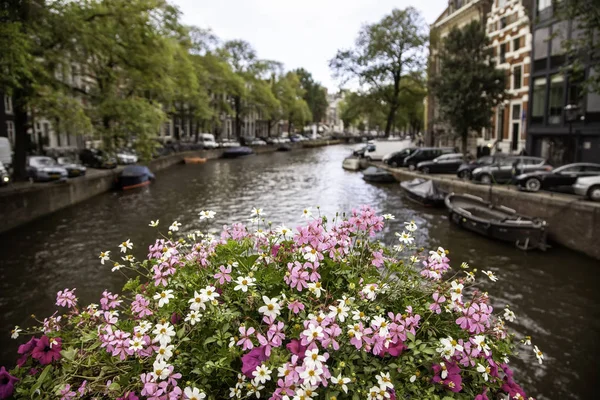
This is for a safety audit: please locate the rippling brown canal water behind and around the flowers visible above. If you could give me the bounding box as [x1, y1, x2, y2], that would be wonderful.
[0, 146, 600, 399]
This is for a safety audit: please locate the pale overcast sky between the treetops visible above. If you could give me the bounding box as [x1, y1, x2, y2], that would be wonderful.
[171, 0, 448, 91]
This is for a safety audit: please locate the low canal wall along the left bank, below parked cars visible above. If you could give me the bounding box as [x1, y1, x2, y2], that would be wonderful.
[0, 141, 340, 233]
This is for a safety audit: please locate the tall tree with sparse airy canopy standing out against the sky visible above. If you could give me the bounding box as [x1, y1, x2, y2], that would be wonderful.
[329, 7, 427, 136]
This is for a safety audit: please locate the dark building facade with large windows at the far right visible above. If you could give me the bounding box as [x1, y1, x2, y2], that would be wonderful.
[527, 0, 600, 165]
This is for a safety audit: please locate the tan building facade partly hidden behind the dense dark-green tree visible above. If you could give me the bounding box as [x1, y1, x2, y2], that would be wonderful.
[425, 0, 492, 152]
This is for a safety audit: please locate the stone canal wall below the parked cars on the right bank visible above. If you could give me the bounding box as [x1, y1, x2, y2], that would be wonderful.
[377, 164, 600, 259]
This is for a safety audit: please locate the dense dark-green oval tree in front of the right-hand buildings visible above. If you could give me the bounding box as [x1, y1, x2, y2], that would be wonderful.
[432, 21, 506, 153]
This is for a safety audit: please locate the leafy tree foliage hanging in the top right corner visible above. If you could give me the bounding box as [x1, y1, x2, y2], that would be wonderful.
[557, 0, 600, 93]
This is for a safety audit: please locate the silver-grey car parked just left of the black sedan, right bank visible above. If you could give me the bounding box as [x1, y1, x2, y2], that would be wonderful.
[473, 156, 552, 185]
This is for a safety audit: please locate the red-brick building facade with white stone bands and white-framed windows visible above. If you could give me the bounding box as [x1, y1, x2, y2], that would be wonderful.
[486, 0, 533, 155]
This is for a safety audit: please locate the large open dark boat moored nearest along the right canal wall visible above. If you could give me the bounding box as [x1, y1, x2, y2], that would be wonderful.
[446, 193, 548, 250]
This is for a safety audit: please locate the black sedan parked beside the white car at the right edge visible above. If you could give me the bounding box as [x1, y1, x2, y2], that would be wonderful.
[515, 163, 600, 192]
